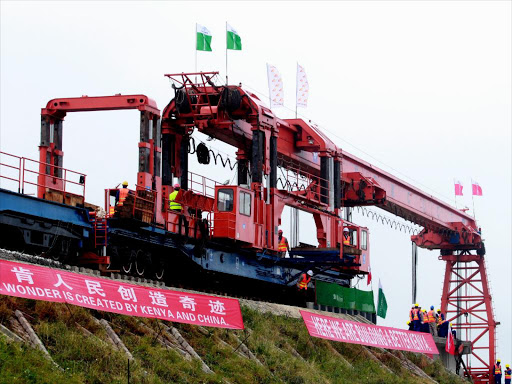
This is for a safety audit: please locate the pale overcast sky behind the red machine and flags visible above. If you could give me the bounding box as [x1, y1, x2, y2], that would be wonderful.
[0, 1, 512, 363]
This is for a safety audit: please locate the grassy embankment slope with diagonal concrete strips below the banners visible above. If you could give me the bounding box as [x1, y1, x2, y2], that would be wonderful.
[0, 296, 463, 384]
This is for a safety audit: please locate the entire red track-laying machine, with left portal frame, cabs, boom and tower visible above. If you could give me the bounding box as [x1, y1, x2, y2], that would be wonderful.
[0, 72, 497, 382]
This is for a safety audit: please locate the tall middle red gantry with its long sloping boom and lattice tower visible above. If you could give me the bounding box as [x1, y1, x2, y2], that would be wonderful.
[162, 72, 497, 382]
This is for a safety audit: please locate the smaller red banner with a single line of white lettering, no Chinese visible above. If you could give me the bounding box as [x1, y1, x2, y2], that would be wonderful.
[300, 311, 439, 354]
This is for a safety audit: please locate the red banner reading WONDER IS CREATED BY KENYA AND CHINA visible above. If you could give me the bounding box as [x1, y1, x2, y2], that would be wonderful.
[0, 260, 244, 329]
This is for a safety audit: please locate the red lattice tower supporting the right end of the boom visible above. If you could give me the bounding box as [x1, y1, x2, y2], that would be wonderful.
[440, 251, 499, 383]
